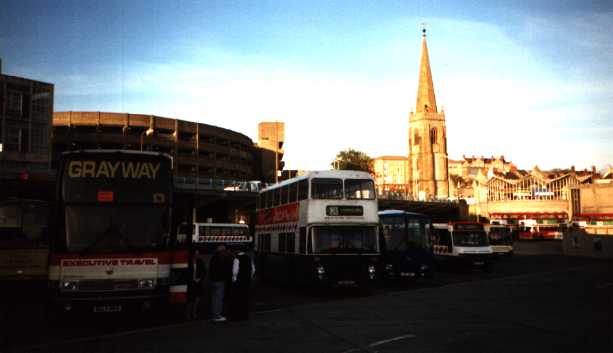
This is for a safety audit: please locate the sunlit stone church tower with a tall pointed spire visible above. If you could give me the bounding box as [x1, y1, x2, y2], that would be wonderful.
[409, 28, 449, 199]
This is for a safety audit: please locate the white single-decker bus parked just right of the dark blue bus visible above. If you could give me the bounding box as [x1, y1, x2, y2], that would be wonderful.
[432, 222, 493, 270]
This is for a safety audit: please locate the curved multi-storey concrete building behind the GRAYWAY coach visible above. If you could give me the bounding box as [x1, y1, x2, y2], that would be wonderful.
[52, 112, 261, 180]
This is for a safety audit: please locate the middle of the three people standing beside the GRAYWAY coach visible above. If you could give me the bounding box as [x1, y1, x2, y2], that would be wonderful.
[209, 245, 232, 322]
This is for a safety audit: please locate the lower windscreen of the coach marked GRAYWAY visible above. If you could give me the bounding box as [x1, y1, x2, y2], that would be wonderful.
[66, 205, 168, 251]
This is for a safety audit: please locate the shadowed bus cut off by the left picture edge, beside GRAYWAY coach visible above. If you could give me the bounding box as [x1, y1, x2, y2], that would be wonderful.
[0, 199, 50, 304]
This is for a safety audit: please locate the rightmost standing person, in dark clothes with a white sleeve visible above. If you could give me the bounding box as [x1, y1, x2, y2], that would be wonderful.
[230, 249, 255, 321]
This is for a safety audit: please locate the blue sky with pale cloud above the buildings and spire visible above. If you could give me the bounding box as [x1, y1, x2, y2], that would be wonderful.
[0, 0, 613, 170]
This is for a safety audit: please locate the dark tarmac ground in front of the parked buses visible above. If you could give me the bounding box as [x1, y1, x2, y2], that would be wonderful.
[0, 241, 613, 353]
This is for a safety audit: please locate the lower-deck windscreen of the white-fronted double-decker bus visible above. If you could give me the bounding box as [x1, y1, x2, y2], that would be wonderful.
[313, 226, 377, 253]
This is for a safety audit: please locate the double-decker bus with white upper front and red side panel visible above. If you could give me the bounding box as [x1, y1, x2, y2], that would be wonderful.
[255, 170, 379, 289]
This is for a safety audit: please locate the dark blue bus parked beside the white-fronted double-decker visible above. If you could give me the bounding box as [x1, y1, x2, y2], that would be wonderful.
[379, 210, 434, 280]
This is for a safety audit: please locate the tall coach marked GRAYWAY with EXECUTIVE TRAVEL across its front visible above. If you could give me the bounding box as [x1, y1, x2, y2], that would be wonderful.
[49, 150, 189, 312]
